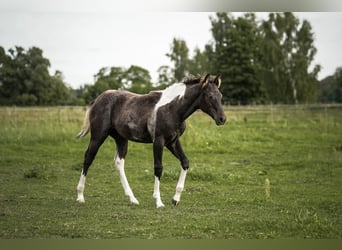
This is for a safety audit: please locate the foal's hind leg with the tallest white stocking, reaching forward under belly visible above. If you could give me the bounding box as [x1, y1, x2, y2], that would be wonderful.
[113, 136, 139, 205]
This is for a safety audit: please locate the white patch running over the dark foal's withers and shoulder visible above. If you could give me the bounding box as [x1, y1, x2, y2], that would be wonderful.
[148, 83, 186, 140]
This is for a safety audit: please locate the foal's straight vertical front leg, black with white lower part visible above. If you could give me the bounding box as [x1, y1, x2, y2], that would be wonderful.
[153, 137, 165, 208]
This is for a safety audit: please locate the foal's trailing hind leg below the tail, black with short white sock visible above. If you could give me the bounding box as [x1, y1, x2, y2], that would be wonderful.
[77, 134, 107, 203]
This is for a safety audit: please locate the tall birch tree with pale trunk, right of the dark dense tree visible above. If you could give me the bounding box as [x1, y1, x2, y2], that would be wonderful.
[260, 12, 320, 103]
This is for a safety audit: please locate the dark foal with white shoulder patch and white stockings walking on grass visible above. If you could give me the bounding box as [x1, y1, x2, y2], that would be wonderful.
[77, 74, 226, 208]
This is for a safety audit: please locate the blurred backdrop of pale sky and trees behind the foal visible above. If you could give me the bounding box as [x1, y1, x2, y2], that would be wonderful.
[0, 0, 342, 106]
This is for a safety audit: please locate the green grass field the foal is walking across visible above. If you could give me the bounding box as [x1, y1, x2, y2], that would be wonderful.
[0, 106, 342, 239]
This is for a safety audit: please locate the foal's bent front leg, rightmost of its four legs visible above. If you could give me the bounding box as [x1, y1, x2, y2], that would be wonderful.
[167, 140, 189, 206]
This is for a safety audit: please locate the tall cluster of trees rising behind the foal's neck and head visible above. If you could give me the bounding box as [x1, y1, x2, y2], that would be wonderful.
[163, 12, 320, 104]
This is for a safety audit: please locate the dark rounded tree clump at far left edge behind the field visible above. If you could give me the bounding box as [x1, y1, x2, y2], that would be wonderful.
[0, 47, 72, 105]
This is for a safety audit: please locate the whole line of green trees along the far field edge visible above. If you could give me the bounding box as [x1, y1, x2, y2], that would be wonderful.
[0, 12, 342, 105]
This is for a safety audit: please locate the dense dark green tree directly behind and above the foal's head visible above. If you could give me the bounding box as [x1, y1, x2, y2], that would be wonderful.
[208, 13, 265, 104]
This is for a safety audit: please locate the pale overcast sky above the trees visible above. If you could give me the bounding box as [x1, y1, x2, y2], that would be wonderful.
[0, 0, 342, 88]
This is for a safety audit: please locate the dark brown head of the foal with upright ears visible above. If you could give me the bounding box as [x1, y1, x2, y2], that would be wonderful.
[199, 74, 227, 125]
